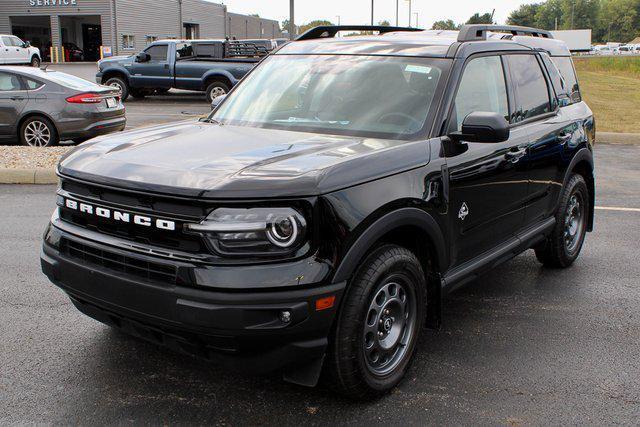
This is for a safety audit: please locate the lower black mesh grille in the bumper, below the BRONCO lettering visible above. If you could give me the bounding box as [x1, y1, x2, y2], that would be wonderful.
[61, 239, 177, 284]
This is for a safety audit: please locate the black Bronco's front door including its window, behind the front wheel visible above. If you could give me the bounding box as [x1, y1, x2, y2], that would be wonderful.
[443, 56, 530, 266]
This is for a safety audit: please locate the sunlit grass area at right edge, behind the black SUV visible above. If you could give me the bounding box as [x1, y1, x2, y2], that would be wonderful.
[574, 56, 640, 133]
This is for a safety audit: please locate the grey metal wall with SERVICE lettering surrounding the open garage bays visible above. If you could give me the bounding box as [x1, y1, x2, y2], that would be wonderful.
[0, 0, 112, 45]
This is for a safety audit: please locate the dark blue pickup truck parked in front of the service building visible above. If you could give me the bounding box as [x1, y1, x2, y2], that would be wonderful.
[96, 40, 268, 102]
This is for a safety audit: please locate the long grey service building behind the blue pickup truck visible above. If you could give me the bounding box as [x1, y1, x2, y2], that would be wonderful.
[0, 0, 282, 61]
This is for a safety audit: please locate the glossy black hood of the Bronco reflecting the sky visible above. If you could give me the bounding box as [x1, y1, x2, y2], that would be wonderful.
[58, 121, 429, 198]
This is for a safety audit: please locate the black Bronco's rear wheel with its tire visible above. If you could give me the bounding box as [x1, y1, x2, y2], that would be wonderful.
[535, 174, 591, 268]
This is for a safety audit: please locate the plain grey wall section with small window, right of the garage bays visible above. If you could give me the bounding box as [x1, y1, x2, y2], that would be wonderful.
[115, 0, 182, 55]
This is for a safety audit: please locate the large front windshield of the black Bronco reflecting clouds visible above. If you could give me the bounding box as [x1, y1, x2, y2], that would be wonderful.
[211, 55, 449, 138]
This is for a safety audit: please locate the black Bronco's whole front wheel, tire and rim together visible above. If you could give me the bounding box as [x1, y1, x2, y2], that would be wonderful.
[323, 245, 427, 400]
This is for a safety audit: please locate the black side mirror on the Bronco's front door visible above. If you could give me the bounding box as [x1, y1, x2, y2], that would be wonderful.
[449, 111, 510, 143]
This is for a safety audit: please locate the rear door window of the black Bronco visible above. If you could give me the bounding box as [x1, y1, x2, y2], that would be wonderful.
[507, 55, 551, 121]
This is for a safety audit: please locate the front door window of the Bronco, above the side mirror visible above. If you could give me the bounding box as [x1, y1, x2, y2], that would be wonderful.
[449, 56, 509, 131]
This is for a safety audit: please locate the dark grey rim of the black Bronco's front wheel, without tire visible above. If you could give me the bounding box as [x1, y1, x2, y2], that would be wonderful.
[362, 275, 417, 376]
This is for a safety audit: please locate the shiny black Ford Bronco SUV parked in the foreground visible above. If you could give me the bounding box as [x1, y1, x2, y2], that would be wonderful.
[42, 25, 595, 398]
